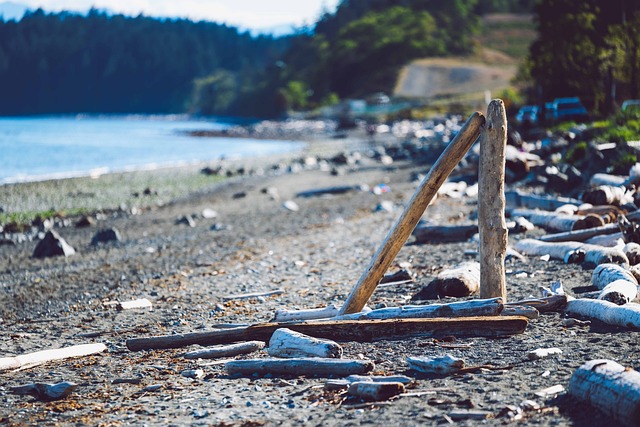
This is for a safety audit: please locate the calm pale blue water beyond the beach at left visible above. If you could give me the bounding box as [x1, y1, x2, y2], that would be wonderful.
[0, 116, 300, 184]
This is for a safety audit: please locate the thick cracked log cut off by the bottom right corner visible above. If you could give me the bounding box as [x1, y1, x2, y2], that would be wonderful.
[569, 359, 640, 426]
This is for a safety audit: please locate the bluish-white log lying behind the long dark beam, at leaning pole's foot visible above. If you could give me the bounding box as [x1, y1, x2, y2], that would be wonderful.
[334, 298, 504, 320]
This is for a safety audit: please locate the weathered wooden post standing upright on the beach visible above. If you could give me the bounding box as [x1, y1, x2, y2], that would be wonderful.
[478, 99, 508, 302]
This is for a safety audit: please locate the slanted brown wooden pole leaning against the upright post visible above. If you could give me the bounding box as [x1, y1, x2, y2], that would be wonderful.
[340, 112, 485, 314]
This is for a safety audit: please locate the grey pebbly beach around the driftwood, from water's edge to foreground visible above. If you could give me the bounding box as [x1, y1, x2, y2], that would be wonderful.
[0, 118, 640, 426]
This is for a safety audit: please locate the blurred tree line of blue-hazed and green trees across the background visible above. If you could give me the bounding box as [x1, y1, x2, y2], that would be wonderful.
[0, 0, 640, 117]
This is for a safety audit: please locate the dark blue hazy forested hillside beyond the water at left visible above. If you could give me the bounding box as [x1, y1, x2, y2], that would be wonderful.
[0, 10, 289, 115]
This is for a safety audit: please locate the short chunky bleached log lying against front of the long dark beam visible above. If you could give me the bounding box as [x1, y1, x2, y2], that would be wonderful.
[267, 328, 342, 359]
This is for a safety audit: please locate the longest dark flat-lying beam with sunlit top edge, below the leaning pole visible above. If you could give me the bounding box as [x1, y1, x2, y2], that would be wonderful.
[126, 316, 528, 351]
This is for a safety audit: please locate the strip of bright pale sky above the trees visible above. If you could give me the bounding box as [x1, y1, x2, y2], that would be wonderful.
[13, 0, 340, 29]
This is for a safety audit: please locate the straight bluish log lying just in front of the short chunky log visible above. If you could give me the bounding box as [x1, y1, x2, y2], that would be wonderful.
[224, 357, 374, 377]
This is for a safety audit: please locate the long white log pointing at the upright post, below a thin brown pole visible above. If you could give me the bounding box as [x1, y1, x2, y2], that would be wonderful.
[515, 239, 629, 265]
